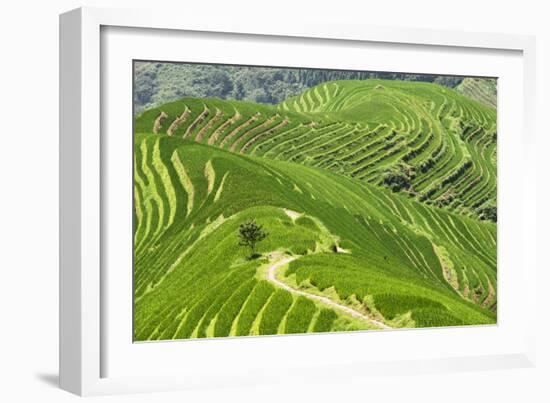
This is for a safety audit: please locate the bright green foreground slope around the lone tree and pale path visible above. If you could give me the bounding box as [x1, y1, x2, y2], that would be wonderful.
[134, 135, 496, 340]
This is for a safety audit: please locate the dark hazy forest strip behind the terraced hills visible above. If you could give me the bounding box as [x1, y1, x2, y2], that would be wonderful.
[134, 62, 470, 113]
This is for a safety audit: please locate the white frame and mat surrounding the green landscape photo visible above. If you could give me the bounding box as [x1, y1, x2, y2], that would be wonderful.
[60, 8, 537, 395]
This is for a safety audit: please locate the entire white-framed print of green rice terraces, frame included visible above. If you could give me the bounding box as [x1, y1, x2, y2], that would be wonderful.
[60, 9, 535, 394]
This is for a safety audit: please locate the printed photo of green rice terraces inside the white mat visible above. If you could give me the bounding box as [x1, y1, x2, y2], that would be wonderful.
[133, 61, 497, 341]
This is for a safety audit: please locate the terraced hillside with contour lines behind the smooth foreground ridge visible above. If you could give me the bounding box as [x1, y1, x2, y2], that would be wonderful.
[135, 80, 497, 220]
